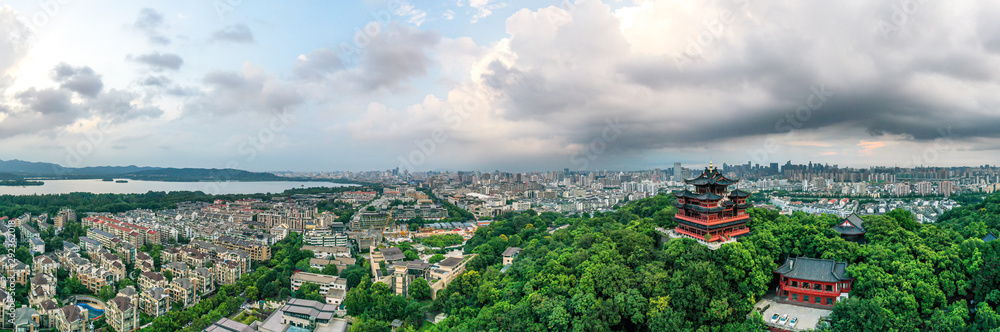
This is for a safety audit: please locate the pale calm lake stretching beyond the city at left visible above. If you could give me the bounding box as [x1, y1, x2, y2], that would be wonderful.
[0, 179, 353, 195]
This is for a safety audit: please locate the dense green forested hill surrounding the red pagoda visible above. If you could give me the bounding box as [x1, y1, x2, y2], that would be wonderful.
[348, 195, 1000, 331]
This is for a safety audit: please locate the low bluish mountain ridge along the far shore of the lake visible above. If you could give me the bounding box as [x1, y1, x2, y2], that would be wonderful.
[0, 160, 287, 181]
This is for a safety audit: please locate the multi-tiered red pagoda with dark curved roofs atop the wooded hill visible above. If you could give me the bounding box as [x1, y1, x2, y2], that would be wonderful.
[674, 164, 751, 242]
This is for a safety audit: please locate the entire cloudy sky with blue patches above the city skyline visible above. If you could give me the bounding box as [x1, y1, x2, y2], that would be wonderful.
[0, 0, 1000, 171]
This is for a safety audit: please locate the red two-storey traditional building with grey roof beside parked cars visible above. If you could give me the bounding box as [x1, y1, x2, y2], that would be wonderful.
[774, 257, 854, 306]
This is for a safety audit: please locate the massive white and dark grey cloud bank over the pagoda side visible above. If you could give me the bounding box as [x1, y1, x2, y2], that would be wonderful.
[466, 0, 1000, 158]
